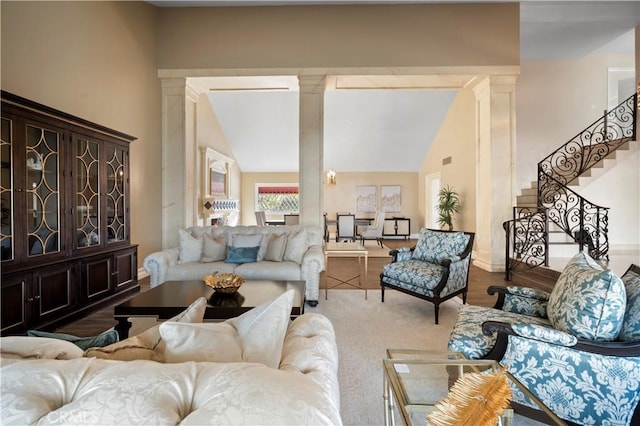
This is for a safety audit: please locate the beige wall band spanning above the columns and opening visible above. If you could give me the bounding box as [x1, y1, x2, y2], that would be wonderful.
[158, 3, 520, 69]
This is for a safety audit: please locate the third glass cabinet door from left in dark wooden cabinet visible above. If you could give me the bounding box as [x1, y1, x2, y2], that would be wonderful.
[74, 138, 101, 249]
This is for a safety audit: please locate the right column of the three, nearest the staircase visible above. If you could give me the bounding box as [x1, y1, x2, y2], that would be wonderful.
[473, 75, 516, 272]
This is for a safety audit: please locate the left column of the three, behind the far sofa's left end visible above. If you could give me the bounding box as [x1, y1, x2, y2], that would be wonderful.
[161, 78, 198, 248]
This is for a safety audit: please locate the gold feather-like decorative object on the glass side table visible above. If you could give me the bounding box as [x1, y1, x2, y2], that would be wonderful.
[427, 366, 511, 426]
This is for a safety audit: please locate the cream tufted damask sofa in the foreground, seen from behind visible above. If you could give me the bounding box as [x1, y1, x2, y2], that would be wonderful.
[0, 313, 342, 426]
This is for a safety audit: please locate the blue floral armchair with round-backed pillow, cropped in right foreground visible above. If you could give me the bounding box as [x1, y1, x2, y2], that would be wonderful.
[449, 253, 640, 425]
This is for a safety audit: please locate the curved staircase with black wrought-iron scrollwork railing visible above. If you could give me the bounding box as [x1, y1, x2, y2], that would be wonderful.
[503, 94, 638, 280]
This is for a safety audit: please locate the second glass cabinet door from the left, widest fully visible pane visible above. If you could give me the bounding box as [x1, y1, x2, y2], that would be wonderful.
[24, 124, 60, 257]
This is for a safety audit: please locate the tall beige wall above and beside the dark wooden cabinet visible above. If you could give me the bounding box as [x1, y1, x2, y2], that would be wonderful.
[0, 1, 162, 264]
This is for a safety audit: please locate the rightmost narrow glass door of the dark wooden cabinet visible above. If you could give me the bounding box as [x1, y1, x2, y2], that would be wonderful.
[105, 145, 129, 243]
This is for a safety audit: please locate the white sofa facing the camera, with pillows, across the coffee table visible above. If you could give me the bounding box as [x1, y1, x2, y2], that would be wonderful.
[142, 226, 325, 306]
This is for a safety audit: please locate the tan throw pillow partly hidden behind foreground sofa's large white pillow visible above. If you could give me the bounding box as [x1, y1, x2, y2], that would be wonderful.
[84, 297, 207, 361]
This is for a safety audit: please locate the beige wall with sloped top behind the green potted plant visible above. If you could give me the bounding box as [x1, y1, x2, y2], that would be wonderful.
[417, 89, 478, 232]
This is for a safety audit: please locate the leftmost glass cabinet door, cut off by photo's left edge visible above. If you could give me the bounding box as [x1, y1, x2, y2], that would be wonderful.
[0, 117, 14, 260]
